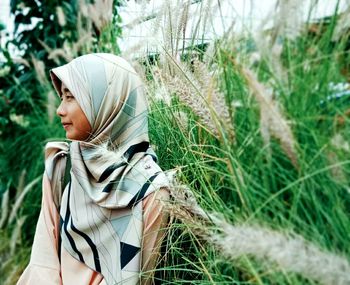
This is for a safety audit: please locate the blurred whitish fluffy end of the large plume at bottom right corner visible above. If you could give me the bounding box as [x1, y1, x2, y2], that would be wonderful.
[210, 222, 350, 285]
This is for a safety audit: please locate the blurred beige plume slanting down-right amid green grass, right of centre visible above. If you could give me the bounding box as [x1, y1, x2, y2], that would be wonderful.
[241, 68, 299, 169]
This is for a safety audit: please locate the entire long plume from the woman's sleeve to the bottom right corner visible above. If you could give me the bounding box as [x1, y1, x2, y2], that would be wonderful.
[165, 175, 350, 285]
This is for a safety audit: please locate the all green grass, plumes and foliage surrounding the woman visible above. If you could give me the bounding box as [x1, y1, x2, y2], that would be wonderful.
[0, 0, 350, 284]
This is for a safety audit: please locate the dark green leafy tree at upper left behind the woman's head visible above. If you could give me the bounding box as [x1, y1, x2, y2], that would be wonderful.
[0, 0, 121, 182]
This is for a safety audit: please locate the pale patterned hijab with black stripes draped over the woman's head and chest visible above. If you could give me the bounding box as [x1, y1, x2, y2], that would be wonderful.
[45, 53, 168, 284]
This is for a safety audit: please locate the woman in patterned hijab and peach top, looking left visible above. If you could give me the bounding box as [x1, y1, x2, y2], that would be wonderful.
[18, 53, 168, 285]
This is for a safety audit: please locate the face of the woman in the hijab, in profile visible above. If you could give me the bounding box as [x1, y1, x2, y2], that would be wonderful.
[57, 82, 91, 141]
